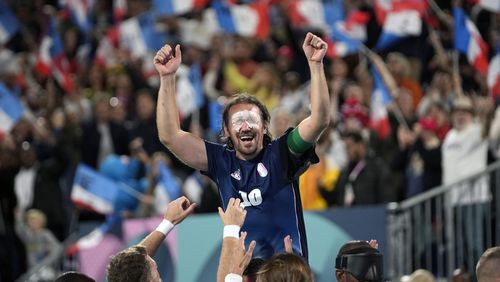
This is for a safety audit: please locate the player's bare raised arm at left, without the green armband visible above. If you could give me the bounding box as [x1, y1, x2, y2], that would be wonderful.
[154, 44, 208, 171]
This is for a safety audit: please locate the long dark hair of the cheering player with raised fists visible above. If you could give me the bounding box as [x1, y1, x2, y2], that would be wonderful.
[220, 93, 273, 149]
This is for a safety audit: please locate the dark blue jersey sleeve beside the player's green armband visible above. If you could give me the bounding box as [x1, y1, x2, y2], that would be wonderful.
[278, 128, 319, 181]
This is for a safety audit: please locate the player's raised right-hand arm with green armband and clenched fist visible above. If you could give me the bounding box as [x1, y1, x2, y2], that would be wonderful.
[288, 32, 330, 154]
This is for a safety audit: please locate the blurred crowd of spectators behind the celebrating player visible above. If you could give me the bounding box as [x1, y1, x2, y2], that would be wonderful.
[0, 0, 500, 281]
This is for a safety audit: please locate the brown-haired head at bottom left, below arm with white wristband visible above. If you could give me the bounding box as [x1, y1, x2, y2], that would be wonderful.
[108, 245, 161, 282]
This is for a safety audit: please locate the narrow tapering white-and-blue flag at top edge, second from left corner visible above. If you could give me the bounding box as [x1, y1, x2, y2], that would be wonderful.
[60, 0, 95, 33]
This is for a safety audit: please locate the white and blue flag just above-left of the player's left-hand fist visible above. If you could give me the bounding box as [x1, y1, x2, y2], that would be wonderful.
[118, 12, 166, 58]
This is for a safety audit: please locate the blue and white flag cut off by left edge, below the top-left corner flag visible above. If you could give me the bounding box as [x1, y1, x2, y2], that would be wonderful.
[0, 83, 24, 133]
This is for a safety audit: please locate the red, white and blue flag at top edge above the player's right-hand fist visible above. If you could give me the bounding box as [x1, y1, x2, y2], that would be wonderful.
[288, 0, 345, 30]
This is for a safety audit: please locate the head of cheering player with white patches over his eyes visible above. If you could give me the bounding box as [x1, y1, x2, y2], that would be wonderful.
[222, 94, 272, 159]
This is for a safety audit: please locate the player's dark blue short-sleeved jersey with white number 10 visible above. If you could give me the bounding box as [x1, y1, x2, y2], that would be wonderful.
[205, 130, 318, 259]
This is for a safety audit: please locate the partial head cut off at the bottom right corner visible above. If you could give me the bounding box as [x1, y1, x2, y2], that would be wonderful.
[476, 246, 500, 282]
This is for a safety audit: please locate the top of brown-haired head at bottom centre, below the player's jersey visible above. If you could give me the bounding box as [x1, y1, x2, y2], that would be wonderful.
[257, 253, 314, 282]
